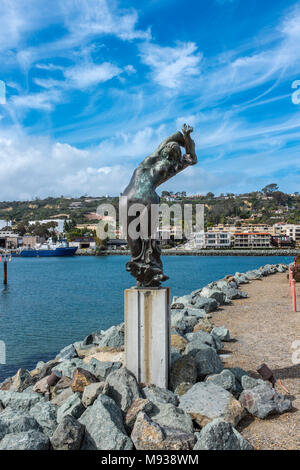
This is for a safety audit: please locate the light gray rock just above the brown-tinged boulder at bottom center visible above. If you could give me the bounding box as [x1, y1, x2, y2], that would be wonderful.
[147, 403, 194, 433]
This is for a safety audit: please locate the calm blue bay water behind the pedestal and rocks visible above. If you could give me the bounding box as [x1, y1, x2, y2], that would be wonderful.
[0, 256, 292, 381]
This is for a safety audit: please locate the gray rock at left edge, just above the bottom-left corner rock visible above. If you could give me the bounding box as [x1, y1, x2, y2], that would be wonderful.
[0, 408, 42, 439]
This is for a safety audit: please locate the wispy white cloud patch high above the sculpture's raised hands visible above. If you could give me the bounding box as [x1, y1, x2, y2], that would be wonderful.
[140, 42, 202, 89]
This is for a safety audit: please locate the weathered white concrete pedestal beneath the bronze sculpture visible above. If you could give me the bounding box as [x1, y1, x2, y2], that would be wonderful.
[124, 287, 170, 388]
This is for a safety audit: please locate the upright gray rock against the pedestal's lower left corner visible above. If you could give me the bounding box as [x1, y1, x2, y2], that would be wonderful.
[103, 367, 141, 413]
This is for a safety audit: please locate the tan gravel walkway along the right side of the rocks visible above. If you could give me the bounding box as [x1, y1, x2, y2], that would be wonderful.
[212, 274, 300, 450]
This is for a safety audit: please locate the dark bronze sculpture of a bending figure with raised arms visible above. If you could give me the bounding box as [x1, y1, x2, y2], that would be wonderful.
[123, 124, 197, 287]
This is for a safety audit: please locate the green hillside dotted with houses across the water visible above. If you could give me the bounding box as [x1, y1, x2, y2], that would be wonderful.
[0, 184, 300, 225]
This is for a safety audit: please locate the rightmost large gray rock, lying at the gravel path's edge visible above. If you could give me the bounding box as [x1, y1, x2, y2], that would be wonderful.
[239, 383, 292, 419]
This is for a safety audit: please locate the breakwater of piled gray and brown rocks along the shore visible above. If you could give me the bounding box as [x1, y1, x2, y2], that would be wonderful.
[0, 264, 292, 450]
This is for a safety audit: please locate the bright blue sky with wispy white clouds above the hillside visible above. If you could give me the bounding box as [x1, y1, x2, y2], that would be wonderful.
[0, 0, 300, 200]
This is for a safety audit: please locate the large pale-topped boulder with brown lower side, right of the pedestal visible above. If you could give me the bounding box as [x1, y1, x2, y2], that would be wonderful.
[179, 382, 244, 427]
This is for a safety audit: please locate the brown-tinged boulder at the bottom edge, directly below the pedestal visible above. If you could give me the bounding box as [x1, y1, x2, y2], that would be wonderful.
[131, 411, 195, 450]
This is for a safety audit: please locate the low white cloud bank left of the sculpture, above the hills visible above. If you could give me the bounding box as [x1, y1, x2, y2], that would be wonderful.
[0, 130, 132, 200]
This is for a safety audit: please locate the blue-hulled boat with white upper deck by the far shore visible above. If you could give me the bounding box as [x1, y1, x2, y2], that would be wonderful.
[13, 238, 77, 258]
